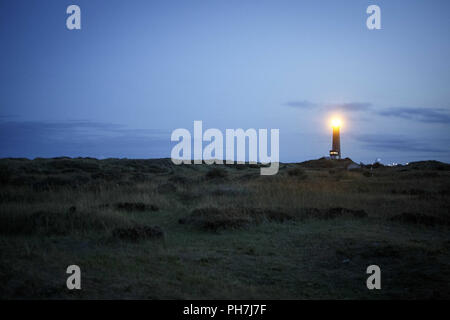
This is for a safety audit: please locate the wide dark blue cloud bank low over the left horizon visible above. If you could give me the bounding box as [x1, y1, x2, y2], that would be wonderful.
[0, 120, 171, 158]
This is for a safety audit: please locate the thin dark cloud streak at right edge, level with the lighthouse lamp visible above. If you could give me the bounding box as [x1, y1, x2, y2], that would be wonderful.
[377, 107, 450, 123]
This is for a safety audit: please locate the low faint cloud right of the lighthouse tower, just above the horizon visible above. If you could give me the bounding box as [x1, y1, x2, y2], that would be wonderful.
[352, 134, 450, 153]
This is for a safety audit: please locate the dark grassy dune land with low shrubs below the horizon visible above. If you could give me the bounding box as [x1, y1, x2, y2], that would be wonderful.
[0, 158, 450, 299]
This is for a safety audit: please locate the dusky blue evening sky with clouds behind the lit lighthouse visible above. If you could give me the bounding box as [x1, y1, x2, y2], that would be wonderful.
[0, 0, 450, 163]
